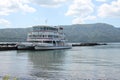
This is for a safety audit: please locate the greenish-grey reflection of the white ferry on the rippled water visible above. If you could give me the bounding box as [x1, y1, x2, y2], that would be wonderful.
[27, 50, 66, 78]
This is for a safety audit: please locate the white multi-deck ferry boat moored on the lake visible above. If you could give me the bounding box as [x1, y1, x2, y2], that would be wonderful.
[18, 26, 71, 50]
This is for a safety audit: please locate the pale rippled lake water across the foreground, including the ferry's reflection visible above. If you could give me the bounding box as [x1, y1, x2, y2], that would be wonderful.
[0, 43, 120, 80]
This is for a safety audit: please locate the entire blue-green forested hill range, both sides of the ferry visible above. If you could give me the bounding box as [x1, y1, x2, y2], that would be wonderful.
[0, 23, 120, 42]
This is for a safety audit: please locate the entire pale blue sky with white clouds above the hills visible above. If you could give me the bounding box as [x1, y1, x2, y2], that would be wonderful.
[0, 0, 120, 28]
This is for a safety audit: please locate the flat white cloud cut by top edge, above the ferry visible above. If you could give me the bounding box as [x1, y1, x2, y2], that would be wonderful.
[31, 0, 67, 7]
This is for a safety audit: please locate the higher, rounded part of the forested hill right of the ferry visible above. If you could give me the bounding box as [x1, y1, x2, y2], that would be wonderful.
[64, 23, 120, 42]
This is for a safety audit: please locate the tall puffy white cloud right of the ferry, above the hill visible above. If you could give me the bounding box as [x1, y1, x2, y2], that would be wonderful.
[65, 0, 95, 24]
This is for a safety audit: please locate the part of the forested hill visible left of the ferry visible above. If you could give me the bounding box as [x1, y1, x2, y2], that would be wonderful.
[0, 28, 31, 42]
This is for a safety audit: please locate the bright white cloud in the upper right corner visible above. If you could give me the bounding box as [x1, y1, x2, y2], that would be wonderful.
[98, 0, 120, 18]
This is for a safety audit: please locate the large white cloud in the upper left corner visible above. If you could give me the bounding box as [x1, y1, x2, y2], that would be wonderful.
[0, 0, 36, 16]
